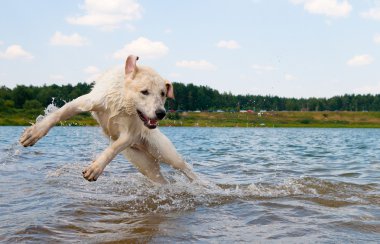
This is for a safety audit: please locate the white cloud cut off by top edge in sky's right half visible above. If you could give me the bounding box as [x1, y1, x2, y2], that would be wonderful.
[290, 0, 352, 17]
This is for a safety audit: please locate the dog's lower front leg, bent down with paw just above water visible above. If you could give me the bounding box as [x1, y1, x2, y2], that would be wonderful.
[82, 135, 131, 181]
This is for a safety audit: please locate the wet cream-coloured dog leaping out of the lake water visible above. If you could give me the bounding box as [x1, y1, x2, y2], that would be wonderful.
[20, 55, 197, 184]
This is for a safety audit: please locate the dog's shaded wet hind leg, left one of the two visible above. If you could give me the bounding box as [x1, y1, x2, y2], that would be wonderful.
[122, 148, 168, 184]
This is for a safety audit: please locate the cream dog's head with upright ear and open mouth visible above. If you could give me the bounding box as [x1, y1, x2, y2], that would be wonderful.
[125, 55, 174, 129]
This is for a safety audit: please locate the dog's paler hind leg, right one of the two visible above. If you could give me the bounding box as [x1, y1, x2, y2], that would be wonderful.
[147, 130, 198, 181]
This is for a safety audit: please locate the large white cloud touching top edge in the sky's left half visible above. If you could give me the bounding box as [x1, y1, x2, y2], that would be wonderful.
[67, 0, 143, 30]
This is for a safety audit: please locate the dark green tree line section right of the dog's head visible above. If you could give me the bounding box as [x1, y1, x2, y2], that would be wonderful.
[169, 83, 380, 111]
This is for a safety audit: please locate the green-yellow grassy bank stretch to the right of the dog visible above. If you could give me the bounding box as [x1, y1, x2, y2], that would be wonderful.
[160, 112, 380, 128]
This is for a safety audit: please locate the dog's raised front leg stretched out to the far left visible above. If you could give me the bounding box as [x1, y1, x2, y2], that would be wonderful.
[20, 94, 96, 147]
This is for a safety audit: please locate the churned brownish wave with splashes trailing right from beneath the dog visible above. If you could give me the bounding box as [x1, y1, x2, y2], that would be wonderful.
[47, 165, 380, 213]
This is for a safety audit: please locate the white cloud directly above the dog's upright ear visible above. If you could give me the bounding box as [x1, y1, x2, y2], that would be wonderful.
[113, 37, 169, 59]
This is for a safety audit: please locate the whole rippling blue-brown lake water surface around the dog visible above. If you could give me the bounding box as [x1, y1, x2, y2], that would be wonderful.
[0, 127, 380, 243]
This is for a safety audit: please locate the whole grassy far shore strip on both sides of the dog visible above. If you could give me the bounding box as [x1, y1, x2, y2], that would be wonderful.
[0, 109, 380, 128]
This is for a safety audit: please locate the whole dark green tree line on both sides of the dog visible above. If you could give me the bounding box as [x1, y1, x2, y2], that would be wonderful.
[0, 82, 380, 112]
